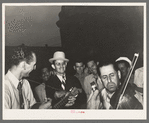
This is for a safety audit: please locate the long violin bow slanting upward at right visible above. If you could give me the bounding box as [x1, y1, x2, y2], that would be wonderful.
[116, 53, 139, 109]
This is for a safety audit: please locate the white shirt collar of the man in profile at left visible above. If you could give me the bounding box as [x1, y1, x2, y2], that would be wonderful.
[7, 70, 19, 88]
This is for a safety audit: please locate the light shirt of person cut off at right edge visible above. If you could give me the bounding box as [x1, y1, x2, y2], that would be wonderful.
[134, 67, 144, 105]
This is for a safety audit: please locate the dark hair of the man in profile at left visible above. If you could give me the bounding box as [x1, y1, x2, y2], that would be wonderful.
[9, 47, 35, 66]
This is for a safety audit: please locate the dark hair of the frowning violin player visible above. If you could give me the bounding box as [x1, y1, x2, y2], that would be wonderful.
[97, 60, 119, 75]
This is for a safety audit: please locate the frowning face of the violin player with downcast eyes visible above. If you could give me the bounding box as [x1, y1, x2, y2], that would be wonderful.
[99, 64, 119, 93]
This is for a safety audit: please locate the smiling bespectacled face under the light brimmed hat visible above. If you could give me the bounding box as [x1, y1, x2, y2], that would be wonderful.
[54, 60, 67, 74]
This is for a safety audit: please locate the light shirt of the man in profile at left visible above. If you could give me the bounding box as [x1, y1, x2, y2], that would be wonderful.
[4, 71, 36, 109]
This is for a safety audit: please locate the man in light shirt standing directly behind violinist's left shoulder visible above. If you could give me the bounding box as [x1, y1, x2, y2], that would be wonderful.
[84, 59, 103, 99]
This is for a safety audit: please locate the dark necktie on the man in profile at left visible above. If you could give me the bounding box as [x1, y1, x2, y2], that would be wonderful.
[17, 82, 24, 109]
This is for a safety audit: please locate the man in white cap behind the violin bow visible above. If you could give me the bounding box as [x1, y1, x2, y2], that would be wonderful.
[116, 57, 134, 85]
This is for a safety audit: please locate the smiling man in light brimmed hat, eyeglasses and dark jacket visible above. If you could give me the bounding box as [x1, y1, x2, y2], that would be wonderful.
[46, 51, 86, 109]
